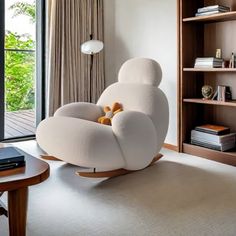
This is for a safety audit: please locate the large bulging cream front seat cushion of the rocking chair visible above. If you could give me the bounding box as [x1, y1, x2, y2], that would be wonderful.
[36, 116, 124, 171]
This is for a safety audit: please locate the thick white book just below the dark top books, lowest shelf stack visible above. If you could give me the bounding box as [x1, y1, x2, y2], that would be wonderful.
[191, 130, 236, 144]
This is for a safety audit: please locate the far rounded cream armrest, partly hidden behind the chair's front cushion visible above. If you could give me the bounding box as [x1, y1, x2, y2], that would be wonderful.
[54, 102, 103, 121]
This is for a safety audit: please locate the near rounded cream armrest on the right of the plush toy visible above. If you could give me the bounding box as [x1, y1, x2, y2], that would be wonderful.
[112, 111, 157, 170]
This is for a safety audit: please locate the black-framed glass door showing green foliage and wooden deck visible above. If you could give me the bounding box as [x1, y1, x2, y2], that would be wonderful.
[0, 0, 43, 140]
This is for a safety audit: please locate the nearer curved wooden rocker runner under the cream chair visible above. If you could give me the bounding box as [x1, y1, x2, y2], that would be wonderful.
[76, 153, 163, 178]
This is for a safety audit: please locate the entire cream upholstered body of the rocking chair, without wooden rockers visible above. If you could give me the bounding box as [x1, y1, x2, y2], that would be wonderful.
[36, 58, 169, 170]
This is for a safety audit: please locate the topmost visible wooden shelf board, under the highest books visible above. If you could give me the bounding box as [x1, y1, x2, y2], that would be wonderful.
[183, 11, 236, 22]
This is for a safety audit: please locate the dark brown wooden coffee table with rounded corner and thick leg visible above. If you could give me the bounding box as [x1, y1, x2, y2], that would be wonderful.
[0, 150, 49, 236]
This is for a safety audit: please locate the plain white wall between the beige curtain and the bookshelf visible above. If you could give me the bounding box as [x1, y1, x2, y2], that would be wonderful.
[104, 0, 177, 145]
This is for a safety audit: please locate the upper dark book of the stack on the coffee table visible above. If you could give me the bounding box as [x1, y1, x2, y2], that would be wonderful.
[0, 147, 25, 166]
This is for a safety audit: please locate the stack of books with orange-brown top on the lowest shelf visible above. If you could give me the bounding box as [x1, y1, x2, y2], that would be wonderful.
[191, 124, 236, 152]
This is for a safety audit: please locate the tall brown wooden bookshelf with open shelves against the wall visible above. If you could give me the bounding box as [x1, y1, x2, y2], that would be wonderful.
[178, 0, 236, 166]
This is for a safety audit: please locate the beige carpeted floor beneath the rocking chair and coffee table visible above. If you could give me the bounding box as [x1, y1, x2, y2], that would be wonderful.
[0, 141, 236, 236]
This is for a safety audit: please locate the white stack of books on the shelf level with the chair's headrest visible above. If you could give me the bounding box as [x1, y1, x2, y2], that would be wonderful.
[194, 57, 223, 68]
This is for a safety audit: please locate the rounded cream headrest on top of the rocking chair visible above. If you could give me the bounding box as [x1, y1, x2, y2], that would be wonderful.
[118, 58, 162, 86]
